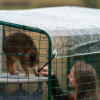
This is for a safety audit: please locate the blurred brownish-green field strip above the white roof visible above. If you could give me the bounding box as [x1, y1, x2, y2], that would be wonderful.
[0, 0, 100, 9]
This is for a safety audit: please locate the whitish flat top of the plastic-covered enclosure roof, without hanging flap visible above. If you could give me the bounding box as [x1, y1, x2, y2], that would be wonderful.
[0, 6, 100, 36]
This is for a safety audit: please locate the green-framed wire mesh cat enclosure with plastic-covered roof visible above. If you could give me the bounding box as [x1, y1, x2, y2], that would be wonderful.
[0, 6, 100, 100]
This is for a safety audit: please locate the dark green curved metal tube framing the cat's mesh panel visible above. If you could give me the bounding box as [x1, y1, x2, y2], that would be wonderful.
[0, 21, 52, 100]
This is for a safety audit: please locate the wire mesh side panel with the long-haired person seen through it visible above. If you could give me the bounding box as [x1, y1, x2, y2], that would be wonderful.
[52, 34, 100, 100]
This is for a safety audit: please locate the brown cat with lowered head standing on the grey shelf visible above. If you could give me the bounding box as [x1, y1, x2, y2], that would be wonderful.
[3, 32, 39, 76]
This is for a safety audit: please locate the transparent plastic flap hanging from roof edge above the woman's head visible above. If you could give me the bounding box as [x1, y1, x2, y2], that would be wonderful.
[52, 29, 100, 58]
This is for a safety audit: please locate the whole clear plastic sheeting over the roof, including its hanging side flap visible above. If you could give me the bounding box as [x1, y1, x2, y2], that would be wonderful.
[0, 6, 100, 57]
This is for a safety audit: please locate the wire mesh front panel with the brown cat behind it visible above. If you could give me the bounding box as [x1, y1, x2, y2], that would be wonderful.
[0, 26, 48, 100]
